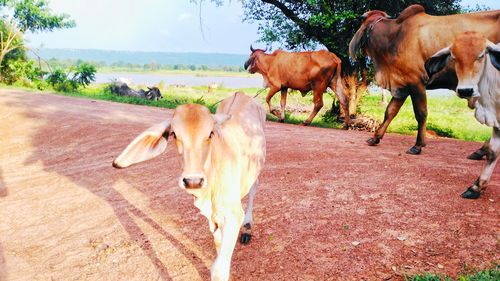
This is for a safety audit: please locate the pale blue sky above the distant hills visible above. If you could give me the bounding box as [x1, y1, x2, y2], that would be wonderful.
[26, 0, 500, 54]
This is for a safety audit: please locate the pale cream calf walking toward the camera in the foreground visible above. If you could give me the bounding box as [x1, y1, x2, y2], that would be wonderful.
[113, 93, 266, 280]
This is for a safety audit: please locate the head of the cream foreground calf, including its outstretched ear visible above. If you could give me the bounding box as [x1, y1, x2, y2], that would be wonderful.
[113, 104, 230, 190]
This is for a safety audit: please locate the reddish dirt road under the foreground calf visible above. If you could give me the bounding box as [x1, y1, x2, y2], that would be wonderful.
[0, 90, 500, 281]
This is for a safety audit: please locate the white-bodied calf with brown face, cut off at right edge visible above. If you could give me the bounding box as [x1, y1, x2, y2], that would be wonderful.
[425, 31, 500, 199]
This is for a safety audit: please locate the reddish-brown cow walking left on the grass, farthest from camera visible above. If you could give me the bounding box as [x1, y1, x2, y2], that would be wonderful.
[245, 46, 350, 129]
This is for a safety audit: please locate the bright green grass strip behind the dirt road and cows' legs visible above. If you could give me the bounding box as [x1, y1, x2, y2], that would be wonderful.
[0, 81, 491, 142]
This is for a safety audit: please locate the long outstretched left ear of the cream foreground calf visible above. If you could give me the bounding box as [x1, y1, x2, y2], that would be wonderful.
[113, 121, 170, 168]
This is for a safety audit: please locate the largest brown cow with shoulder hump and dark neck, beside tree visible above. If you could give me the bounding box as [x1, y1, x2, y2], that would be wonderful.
[349, 5, 500, 154]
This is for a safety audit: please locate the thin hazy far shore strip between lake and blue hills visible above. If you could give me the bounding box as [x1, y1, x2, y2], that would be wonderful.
[40, 58, 245, 72]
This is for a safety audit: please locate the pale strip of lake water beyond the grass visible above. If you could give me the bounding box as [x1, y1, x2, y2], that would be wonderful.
[95, 72, 263, 88]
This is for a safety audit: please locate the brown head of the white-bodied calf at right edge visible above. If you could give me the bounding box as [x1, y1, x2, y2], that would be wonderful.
[425, 31, 500, 99]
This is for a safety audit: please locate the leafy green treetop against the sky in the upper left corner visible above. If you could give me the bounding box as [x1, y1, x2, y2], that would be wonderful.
[0, 0, 75, 67]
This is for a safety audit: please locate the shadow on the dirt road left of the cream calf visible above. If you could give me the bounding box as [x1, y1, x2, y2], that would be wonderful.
[14, 97, 210, 280]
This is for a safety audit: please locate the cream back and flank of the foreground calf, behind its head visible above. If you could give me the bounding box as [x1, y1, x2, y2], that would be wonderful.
[217, 92, 266, 197]
